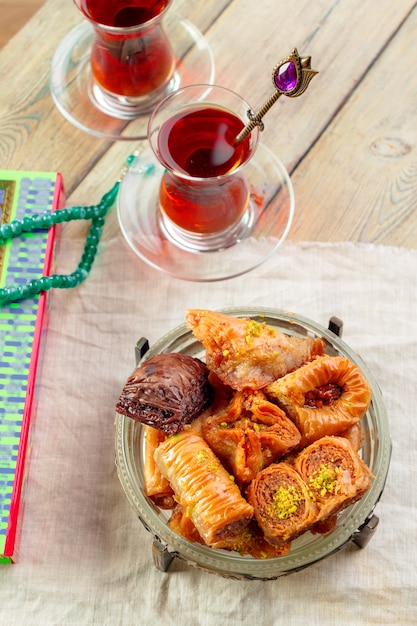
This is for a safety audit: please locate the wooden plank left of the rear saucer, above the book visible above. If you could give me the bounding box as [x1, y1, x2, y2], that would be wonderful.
[0, 0, 109, 177]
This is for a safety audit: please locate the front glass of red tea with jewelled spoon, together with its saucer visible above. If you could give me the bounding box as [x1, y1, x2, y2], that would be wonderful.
[118, 85, 294, 281]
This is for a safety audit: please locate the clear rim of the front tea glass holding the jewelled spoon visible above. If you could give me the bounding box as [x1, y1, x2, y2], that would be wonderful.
[147, 83, 260, 184]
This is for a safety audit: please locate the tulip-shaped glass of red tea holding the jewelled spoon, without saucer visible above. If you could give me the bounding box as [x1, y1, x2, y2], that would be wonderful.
[148, 85, 259, 250]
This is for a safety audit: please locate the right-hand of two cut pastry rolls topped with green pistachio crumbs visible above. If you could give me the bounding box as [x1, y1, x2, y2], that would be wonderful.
[294, 437, 371, 521]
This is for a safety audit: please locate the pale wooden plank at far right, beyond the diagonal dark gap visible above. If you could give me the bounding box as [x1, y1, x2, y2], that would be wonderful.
[290, 9, 417, 248]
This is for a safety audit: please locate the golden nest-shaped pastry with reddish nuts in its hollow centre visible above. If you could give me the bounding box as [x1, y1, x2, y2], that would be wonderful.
[265, 356, 371, 447]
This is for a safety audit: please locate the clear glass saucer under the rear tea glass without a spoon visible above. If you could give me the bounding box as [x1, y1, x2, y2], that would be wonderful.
[49, 12, 214, 141]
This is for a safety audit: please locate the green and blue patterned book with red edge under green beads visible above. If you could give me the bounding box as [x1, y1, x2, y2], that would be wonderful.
[0, 170, 64, 563]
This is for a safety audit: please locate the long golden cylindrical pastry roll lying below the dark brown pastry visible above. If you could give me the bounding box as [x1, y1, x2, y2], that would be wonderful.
[154, 429, 253, 546]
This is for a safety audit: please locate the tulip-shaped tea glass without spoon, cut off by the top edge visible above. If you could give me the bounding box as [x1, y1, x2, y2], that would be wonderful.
[74, 0, 175, 119]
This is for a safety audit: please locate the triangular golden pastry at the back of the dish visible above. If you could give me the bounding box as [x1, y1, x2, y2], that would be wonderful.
[186, 309, 324, 390]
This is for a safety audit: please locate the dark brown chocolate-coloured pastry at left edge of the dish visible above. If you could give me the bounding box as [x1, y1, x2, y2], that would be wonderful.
[116, 353, 212, 435]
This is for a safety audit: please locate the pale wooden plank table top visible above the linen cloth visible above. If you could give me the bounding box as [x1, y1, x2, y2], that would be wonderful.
[0, 0, 417, 248]
